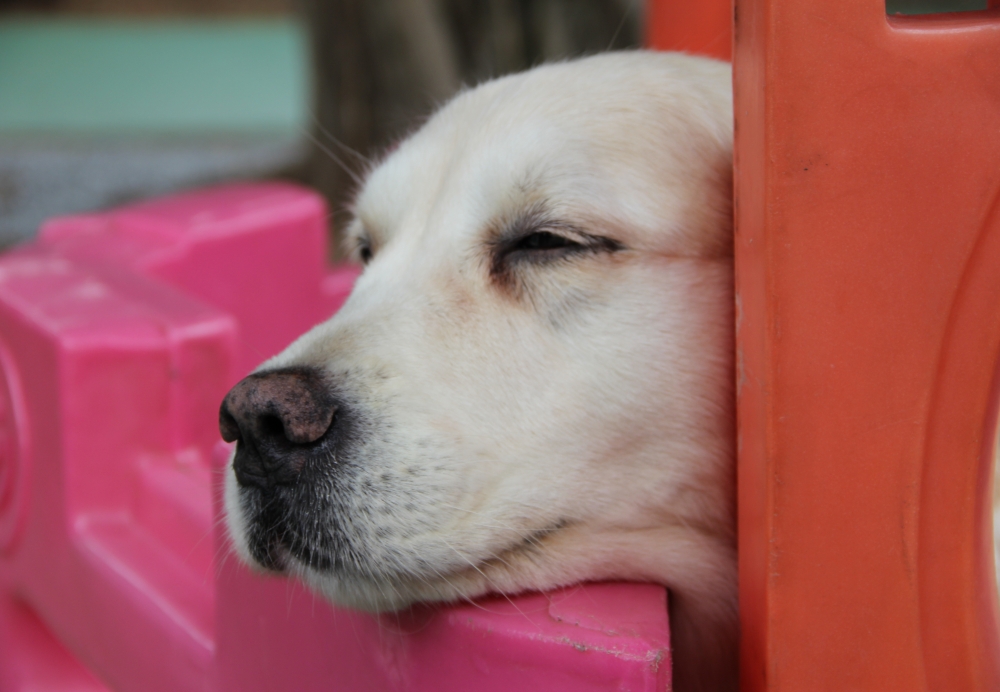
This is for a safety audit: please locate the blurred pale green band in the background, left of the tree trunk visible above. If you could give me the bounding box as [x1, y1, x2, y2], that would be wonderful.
[0, 19, 309, 135]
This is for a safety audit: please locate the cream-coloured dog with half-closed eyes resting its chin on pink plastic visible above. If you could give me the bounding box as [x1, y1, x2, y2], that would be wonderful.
[220, 51, 738, 692]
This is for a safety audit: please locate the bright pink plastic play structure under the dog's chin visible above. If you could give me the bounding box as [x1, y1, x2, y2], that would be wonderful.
[0, 184, 670, 692]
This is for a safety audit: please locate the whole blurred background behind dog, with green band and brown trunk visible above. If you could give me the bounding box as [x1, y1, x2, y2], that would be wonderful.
[0, 0, 645, 255]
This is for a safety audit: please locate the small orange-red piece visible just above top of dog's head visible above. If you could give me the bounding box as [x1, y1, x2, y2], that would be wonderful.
[646, 0, 732, 60]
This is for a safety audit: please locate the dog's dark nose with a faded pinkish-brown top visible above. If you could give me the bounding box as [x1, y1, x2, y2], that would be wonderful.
[219, 368, 337, 489]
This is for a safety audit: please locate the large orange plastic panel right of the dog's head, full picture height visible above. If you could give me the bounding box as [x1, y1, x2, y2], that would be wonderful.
[735, 0, 1000, 692]
